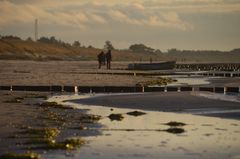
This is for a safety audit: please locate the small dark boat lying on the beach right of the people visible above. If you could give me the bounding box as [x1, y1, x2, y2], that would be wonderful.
[128, 61, 176, 70]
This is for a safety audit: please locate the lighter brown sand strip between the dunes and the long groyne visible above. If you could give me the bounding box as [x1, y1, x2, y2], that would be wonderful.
[0, 60, 240, 87]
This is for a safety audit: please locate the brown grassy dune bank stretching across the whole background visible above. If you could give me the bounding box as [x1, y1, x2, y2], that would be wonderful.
[0, 38, 240, 63]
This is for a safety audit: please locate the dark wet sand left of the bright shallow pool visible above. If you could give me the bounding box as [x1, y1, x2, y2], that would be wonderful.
[0, 91, 102, 158]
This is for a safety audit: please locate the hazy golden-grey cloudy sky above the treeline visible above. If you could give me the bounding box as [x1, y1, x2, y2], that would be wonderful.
[0, 0, 240, 51]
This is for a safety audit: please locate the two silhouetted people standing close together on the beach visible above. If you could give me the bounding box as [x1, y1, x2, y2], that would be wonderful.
[98, 50, 112, 69]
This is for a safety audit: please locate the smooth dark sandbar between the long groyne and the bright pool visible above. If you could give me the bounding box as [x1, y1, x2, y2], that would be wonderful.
[70, 92, 240, 119]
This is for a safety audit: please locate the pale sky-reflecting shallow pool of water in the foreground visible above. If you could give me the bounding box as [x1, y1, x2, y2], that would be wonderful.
[47, 96, 240, 159]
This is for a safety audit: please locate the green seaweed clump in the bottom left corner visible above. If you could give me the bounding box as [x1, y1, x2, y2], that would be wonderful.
[0, 152, 41, 159]
